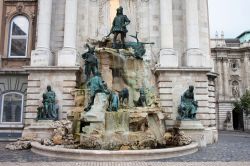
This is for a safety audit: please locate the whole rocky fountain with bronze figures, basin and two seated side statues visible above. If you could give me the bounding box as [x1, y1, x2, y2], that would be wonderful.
[6, 7, 198, 160]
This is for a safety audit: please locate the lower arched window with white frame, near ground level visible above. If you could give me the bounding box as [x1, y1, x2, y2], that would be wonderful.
[1, 92, 23, 123]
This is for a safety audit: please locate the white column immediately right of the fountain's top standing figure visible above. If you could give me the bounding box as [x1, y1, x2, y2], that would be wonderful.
[159, 0, 178, 67]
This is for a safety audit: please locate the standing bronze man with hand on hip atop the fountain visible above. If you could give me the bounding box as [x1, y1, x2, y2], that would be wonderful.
[108, 7, 130, 49]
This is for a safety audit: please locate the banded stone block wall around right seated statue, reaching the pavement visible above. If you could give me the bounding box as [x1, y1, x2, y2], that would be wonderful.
[155, 68, 218, 144]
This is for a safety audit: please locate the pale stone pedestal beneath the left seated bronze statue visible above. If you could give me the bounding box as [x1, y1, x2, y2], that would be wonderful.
[22, 120, 55, 140]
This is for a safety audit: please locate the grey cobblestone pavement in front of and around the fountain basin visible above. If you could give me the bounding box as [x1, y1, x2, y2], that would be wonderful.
[0, 132, 250, 166]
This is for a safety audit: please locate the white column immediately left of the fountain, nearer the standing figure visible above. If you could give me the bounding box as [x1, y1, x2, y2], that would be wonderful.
[57, 0, 77, 66]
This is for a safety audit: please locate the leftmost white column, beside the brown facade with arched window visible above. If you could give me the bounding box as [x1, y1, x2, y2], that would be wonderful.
[31, 0, 52, 66]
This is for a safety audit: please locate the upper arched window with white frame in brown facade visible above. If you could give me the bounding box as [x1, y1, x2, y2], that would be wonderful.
[8, 15, 29, 58]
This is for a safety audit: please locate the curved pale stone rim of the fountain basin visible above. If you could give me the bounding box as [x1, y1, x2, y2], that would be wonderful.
[31, 142, 198, 161]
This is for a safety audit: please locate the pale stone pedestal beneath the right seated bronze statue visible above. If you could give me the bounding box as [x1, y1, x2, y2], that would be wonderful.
[175, 120, 207, 147]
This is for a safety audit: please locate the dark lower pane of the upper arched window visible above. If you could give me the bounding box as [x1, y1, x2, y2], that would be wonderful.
[10, 39, 26, 56]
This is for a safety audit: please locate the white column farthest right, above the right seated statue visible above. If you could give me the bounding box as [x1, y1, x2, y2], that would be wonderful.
[186, 0, 206, 67]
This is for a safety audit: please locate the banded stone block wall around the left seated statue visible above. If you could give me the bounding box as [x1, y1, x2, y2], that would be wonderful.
[24, 67, 79, 125]
